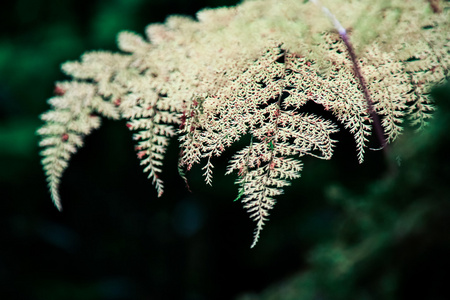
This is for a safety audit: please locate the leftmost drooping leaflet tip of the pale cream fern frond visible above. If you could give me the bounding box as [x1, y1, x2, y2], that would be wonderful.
[37, 82, 118, 210]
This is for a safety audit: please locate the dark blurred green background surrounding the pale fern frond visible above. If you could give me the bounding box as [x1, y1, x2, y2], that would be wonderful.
[0, 0, 450, 300]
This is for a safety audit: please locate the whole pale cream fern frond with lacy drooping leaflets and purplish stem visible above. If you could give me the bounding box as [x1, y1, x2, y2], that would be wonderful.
[39, 0, 450, 247]
